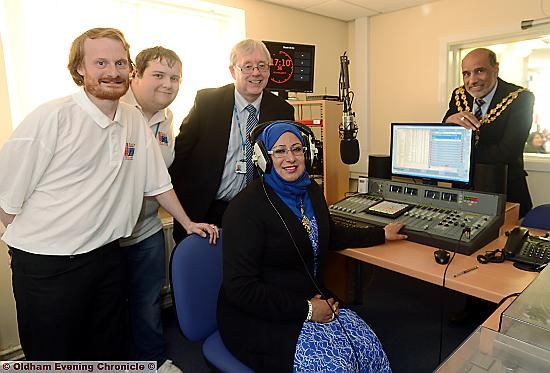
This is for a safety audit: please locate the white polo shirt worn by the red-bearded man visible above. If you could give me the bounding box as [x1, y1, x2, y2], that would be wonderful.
[0, 89, 172, 255]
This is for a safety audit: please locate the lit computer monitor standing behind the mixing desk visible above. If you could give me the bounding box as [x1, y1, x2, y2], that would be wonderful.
[390, 123, 473, 186]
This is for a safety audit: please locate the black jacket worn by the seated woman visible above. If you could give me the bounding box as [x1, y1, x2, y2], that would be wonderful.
[218, 179, 385, 372]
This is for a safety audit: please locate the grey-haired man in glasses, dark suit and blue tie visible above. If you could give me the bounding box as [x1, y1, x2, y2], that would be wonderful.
[169, 39, 294, 242]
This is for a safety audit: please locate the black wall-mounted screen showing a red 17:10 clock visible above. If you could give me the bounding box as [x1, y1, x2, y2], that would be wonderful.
[263, 40, 315, 92]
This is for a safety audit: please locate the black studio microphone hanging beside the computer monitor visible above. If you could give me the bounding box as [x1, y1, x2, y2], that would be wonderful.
[340, 52, 359, 164]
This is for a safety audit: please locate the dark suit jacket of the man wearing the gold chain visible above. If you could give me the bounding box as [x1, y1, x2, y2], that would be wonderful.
[443, 78, 535, 217]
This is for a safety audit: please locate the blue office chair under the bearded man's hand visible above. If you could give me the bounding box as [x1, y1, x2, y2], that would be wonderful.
[170, 232, 252, 373]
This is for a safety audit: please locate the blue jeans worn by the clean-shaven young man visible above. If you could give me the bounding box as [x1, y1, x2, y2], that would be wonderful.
[124, 230, 167, 366]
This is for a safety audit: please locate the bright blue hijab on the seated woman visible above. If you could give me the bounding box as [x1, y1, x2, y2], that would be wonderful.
[258, 121, 313, 220]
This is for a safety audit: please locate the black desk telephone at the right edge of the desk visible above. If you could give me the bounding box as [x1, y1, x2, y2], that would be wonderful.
[503, 227, 550, 271]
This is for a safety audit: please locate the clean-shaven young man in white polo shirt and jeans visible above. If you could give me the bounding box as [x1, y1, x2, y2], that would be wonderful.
[119, 46, 182, 373]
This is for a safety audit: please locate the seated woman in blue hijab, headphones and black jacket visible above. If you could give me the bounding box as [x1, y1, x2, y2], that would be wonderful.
[218, 121, 406, 372]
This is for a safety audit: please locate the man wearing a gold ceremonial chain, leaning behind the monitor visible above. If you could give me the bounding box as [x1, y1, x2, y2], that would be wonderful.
[443, 48, 535, 217]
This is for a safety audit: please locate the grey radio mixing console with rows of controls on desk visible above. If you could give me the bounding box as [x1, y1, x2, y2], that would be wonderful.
[329, 178, 506, 255]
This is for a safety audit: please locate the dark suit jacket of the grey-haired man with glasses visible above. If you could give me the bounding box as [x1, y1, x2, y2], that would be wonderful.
[169, 84, 294, 238]
